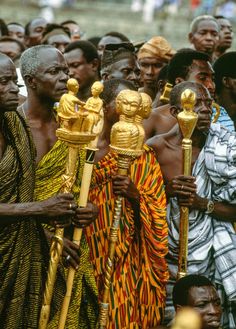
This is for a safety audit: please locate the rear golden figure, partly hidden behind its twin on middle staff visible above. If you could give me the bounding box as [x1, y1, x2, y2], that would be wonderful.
[134, 93, 152, 150]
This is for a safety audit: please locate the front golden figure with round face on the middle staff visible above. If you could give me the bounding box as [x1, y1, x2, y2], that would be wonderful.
[111, 90, 142, 150]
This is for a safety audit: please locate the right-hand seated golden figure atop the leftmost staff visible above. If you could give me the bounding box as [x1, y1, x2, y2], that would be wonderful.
[73, 81, 103, 133]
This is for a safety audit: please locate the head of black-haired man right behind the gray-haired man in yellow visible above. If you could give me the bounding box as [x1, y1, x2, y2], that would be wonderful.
[65, 40, 99, 102]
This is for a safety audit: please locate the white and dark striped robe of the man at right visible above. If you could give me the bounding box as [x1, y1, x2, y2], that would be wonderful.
[166, 124, 236, 329]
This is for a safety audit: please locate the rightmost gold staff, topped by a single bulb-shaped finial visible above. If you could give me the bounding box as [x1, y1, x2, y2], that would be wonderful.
[177, 89, 198, 278]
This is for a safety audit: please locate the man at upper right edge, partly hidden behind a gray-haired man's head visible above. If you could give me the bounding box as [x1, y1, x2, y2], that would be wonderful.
[214, 16, 234, 60]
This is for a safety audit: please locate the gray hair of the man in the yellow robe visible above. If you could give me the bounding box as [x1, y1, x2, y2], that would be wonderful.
[20, 45, 55, 80]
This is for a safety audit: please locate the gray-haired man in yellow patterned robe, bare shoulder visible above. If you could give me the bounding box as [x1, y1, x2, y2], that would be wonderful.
[19, 45, 98, 329]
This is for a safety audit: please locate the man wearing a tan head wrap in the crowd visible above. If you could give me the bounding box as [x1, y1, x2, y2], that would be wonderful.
[138, 37, 175, 101]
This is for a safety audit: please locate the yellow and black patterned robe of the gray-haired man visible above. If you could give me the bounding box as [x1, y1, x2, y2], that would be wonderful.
[35, 141, 98, 329]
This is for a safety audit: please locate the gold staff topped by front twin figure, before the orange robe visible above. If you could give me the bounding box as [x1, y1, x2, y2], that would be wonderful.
[99, 90, 148, 329]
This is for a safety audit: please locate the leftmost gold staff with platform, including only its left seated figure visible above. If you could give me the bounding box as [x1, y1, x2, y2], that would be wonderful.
[39, 79, 96, 329]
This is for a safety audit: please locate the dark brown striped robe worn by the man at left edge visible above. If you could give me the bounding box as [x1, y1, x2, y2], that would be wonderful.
[0, 112, 48, 329]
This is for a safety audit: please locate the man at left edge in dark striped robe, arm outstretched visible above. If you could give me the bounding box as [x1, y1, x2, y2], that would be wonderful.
[0, 54, 76, 329]
